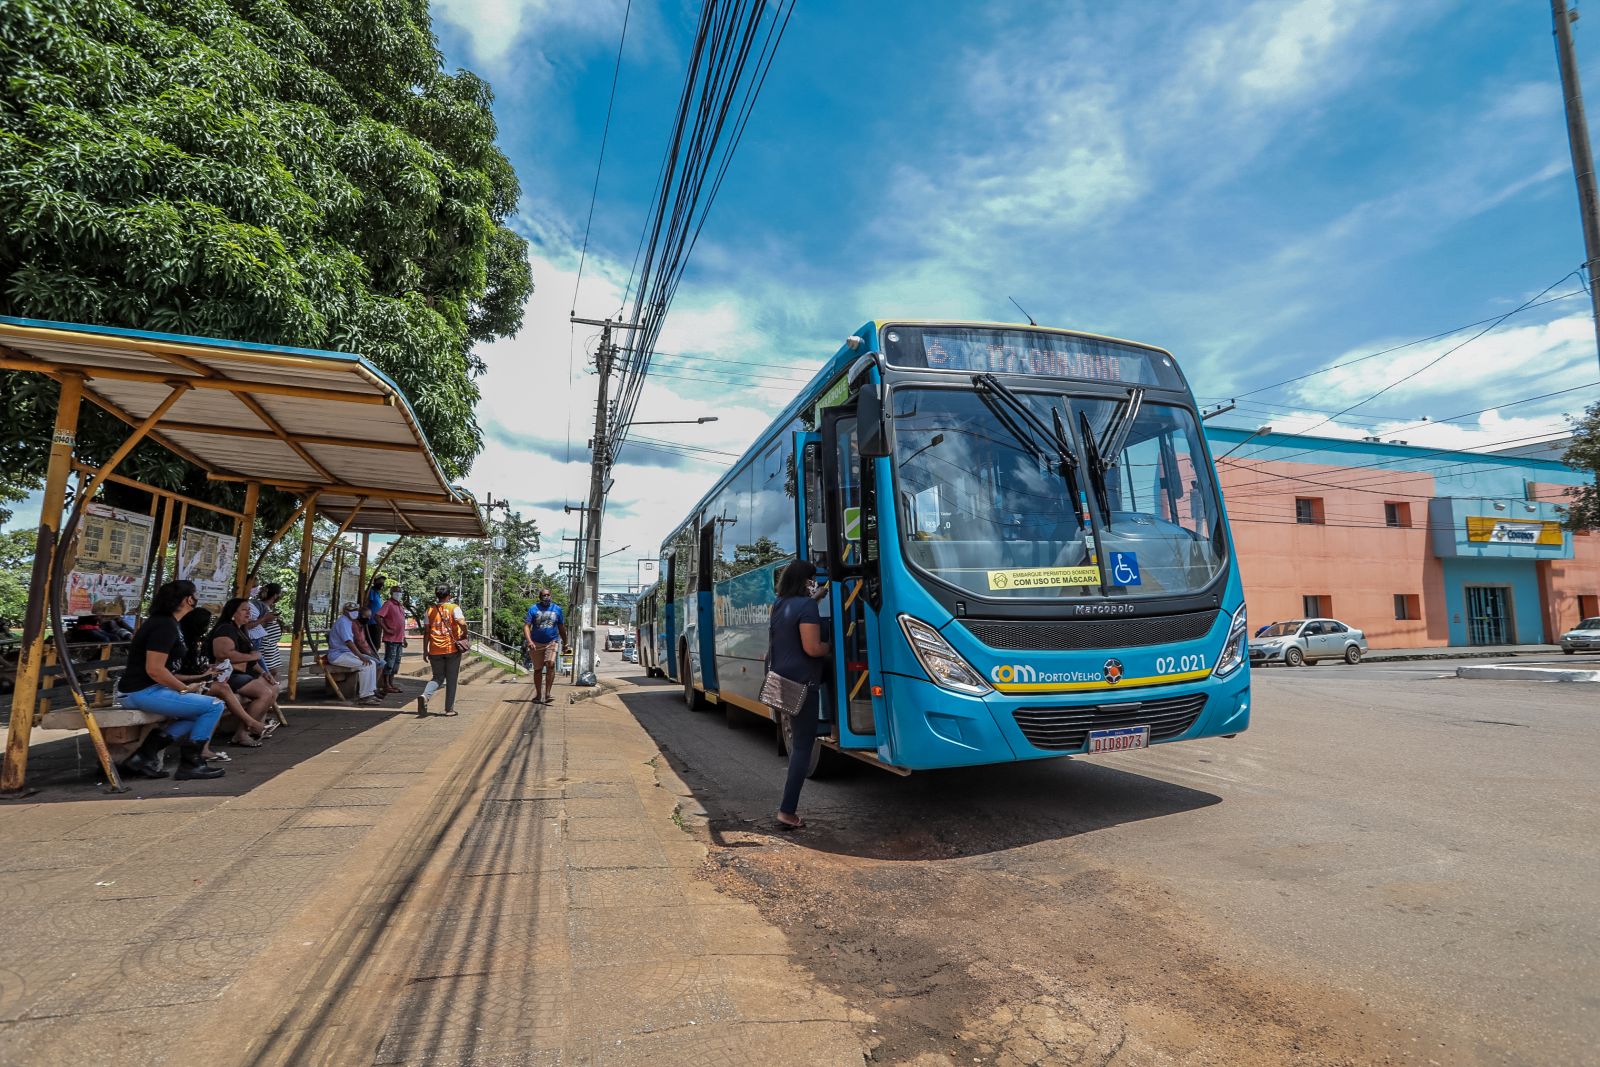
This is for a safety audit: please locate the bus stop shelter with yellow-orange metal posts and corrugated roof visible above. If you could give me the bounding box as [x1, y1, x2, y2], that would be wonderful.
[0, 315, 486, 793]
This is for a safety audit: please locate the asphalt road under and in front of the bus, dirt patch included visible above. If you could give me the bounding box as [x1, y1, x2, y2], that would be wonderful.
[611, 657, 1600, 1065]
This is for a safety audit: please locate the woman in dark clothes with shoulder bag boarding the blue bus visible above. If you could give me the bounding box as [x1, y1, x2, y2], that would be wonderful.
[768, 560, 829, 830]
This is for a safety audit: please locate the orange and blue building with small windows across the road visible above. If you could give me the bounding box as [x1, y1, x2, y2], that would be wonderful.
[1206, 427, 1600, 648]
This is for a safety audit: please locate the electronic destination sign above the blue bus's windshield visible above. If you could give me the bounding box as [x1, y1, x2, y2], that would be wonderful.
[883, 326, 1184, 389]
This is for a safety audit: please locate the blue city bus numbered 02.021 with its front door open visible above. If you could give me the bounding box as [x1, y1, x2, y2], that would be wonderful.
[654, 320, 1250, 773]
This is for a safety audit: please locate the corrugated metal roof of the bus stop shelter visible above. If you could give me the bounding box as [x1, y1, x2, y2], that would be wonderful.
[0, 315, 485, 537]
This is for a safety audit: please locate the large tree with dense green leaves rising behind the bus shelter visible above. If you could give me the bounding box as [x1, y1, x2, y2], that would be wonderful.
[0, 0, 533, 502]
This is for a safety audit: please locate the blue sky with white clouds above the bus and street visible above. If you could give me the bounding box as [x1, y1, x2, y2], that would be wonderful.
[434, 0, 1600, 585]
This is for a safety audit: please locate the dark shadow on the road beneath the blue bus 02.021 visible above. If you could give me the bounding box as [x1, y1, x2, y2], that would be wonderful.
[621, 677, 1221, 861]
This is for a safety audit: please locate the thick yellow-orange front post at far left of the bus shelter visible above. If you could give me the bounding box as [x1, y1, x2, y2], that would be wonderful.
[0, 374, 83, 792]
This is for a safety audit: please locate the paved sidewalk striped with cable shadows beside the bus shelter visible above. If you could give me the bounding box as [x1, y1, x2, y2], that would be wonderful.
[0, 662, 866, 1065]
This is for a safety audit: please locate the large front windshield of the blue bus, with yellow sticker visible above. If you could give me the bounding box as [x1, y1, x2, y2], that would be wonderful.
[893, 384, 1226, 600]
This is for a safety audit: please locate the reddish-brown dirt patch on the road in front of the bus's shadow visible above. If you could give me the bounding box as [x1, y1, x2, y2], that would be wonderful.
[706, 830, 1499, 1067]
